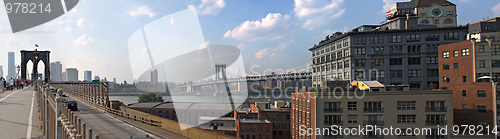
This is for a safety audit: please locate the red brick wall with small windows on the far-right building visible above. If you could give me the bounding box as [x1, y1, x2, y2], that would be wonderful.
[438, 41, 493, 125]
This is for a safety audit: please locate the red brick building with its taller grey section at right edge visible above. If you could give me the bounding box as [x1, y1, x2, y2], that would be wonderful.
[438, 17, 500, 126]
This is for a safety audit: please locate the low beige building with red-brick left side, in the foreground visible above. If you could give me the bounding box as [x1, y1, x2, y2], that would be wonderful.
[291, 87, 453, 139]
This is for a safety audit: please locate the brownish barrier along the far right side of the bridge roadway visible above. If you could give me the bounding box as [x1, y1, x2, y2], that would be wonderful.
[51, 83, 236, 139]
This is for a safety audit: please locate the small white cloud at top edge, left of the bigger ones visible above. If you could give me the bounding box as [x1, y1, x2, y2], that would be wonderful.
[189, 0, 226, 15]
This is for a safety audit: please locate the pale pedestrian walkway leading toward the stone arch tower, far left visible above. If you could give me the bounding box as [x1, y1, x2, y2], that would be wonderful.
[0, 87, 41, 139]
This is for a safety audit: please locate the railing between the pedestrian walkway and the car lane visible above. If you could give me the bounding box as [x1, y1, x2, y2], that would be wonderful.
[35, 82, 99, 139]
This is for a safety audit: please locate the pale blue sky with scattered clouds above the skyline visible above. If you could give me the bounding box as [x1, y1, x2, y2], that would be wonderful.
[0, 0, 500, 82]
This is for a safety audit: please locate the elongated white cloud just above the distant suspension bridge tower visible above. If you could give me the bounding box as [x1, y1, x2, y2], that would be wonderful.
[224, 13, 290, 41]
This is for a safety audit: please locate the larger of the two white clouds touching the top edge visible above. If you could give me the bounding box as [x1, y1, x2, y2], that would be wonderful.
[293, 0, 345, 29]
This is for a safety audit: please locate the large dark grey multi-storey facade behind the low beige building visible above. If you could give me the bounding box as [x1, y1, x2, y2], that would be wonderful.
[309, 27, 468, 88]
